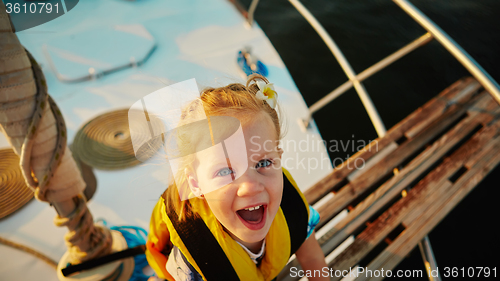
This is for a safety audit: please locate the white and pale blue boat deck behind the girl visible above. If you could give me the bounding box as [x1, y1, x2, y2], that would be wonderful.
[0, 0, 332, 280]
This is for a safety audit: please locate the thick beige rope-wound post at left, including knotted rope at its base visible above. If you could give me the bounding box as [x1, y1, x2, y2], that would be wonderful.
[0, 1, 112, 263]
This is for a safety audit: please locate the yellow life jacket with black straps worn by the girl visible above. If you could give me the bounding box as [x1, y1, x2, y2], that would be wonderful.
[146, 169, 309, 281]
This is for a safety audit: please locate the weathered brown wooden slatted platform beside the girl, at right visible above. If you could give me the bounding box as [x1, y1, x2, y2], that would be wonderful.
[278, 75, 500, 280]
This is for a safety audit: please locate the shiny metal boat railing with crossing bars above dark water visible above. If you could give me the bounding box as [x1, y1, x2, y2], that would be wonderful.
[247, 0, 500, 137]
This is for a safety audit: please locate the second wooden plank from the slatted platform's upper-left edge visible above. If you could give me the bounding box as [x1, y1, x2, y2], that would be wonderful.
[318, 87, 477, 227]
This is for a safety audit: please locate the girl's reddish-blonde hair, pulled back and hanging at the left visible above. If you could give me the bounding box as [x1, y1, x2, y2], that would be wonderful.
[163, 74, 282, 221]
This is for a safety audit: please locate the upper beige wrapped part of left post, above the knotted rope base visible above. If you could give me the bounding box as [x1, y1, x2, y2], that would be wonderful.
[0, 21, 85, 202]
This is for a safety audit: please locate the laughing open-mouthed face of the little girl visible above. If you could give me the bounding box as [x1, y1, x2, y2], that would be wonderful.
[188, 112, 283, 249]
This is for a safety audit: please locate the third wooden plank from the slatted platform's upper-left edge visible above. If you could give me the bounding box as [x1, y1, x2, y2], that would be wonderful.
[319, 93, 499, 253]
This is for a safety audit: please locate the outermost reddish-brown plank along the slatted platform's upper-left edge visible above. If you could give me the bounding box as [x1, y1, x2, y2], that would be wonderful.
[304, 77, 480, 204]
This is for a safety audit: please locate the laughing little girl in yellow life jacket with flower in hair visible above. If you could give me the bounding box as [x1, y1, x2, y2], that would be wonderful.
[146, 75, 328, 280]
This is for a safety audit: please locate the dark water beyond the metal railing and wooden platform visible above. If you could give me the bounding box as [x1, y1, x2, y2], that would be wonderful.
[242, 0, 500, 279]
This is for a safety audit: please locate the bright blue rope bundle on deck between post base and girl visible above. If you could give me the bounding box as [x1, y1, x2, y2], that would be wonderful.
[99, 219, 151, 281]
